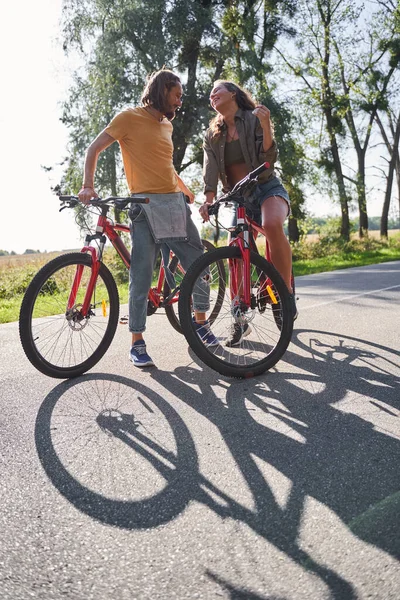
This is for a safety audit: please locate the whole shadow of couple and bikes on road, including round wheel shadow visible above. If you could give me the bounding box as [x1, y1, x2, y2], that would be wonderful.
[35, 330, 400, 599]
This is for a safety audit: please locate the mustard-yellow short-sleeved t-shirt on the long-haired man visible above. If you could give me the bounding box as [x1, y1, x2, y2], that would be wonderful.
[105, 106, 179, 194]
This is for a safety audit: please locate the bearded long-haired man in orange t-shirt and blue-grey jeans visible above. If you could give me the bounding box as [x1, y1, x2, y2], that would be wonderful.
[78, 69, 218, 367]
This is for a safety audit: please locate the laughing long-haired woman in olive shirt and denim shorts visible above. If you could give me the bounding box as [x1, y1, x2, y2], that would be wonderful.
[200, 80, 297, 345]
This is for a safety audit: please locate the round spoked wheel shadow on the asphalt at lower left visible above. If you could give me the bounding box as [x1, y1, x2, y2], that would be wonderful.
[35, 374, 198, 529]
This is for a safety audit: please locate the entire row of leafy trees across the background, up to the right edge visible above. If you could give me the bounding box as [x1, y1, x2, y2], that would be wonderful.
[60, 0, 400, 240]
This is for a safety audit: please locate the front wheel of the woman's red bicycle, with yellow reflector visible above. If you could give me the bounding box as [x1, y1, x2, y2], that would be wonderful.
[179, 247, 293, 377]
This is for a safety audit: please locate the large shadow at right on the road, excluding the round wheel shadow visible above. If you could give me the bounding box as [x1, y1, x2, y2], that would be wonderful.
[153, 330, 400, 598]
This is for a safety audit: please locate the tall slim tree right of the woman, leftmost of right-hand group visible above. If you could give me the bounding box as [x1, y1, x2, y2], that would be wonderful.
[278, 0, 368, 240]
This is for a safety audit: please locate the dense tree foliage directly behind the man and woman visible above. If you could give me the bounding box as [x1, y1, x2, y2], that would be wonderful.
[62, 0, 303, 239]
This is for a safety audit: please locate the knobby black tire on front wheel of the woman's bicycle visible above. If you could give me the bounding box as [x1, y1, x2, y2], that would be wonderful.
[179, 247, 293, 378]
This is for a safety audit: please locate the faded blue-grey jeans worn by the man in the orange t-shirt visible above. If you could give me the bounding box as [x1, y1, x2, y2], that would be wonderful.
[129, 211, 210, 333]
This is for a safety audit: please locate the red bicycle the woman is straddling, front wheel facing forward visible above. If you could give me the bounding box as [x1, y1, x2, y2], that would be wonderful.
[179, 163, 295, 377]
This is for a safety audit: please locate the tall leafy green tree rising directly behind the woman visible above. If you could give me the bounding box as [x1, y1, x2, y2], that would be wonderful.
[216, 1, 306, 241]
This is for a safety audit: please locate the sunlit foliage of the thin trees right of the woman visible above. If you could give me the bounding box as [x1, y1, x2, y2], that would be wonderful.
[278, 0, 399, 239]
